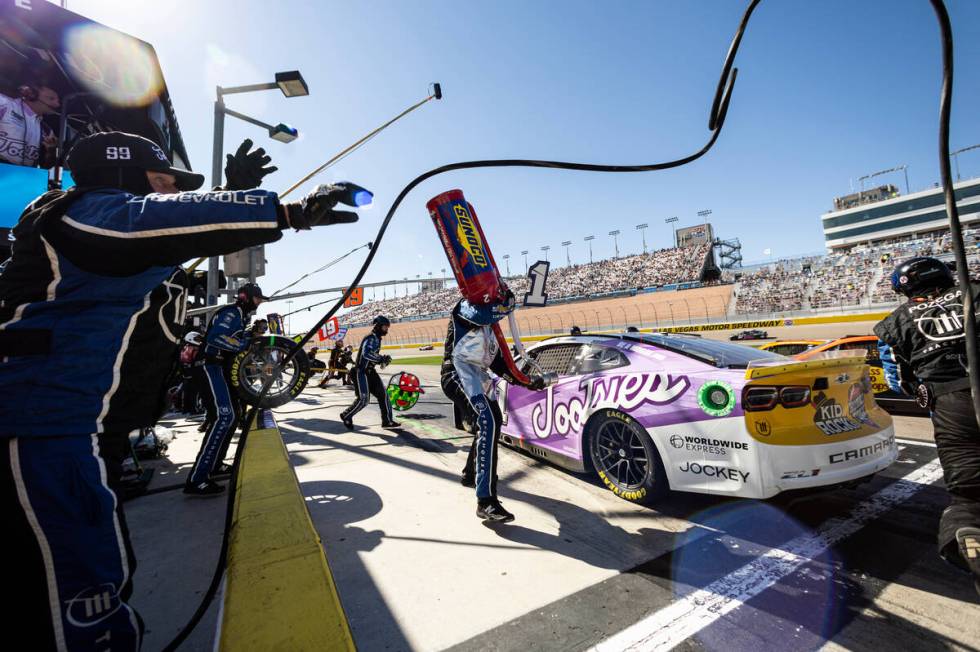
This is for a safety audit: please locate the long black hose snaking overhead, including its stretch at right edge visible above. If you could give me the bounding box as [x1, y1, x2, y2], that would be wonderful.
[165, 0, 980, 651]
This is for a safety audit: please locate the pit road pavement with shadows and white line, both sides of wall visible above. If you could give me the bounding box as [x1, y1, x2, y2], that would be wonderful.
[134, 360, 980, 652]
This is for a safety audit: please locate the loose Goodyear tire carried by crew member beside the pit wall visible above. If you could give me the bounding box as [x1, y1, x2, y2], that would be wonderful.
[229, 337, 310, 408]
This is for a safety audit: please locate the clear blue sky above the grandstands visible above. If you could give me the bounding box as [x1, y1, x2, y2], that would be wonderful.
[68, 0, 980, 331]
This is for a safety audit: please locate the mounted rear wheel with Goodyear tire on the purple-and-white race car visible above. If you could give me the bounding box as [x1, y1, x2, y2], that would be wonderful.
[587, 409, 669, 505]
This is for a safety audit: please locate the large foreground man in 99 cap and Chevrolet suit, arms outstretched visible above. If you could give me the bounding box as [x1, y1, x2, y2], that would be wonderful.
[0, 132, 372, 650]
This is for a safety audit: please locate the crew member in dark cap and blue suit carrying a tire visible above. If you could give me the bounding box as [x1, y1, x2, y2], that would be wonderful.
[184, 283, 266, 496]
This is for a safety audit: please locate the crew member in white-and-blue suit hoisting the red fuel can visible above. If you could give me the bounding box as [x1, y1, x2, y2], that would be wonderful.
[442, 287, 544, 523]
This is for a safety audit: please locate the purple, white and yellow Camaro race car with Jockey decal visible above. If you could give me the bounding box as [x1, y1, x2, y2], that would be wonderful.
[497, 333, 898, 504]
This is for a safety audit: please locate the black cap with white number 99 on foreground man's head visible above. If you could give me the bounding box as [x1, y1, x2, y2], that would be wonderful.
[65, 131, 204, 191]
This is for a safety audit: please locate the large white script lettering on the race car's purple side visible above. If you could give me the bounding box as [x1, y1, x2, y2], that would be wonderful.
[531, 373, 691, 439]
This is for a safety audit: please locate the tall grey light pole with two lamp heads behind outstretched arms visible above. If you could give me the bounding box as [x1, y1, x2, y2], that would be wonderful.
[207, 70, 310, 306]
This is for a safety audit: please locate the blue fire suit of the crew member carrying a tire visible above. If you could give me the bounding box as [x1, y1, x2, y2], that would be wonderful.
[187, 304, 251, 486]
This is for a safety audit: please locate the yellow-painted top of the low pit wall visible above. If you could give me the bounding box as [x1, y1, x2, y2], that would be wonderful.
[219, 412, 356, 652]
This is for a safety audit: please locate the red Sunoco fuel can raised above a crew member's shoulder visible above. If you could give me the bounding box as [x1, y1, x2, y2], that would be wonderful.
[425, 190, 503, 305]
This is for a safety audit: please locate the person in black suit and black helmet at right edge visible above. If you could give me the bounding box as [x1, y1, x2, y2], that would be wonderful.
[875, 258, 980, 592]
